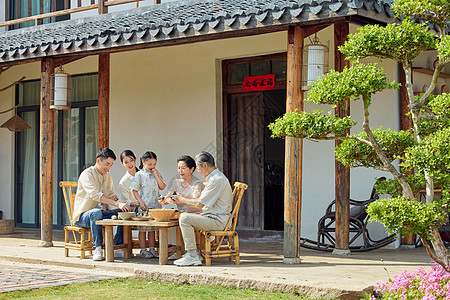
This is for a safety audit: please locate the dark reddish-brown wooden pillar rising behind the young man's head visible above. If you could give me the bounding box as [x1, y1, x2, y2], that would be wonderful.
[97, 53, 110, 149]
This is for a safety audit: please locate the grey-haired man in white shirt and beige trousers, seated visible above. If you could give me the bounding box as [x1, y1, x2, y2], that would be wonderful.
[172, 152, 233, 266]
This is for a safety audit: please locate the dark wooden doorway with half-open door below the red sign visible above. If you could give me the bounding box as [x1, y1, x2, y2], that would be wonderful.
[223, 53, 286, 231]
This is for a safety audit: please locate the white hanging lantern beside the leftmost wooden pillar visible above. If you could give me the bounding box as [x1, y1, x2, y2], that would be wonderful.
[50, 66, 72, 110]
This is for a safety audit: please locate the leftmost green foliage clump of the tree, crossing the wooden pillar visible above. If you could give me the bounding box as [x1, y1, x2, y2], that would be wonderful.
[269, 110, 357, 139]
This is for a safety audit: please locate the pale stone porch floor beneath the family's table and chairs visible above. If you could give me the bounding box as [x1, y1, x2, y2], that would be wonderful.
[0, 229, 430, 300]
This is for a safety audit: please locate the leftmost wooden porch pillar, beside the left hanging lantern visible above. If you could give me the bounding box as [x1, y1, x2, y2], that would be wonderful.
[39, 58, 55, 247]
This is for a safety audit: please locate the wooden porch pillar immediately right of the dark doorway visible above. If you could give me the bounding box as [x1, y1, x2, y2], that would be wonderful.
[283, 26, 305, 264]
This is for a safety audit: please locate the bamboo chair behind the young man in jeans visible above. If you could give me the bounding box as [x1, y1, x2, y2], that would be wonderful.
[59, 181, 93, 258]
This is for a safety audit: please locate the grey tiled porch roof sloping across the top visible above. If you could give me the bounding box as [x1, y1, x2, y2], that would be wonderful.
[0, 0, 394, 63]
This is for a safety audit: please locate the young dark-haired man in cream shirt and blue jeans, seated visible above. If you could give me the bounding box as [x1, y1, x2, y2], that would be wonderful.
[73, 148, 131, 260]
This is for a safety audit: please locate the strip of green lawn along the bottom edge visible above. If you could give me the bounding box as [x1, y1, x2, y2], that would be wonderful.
[0, 278, 308, 300]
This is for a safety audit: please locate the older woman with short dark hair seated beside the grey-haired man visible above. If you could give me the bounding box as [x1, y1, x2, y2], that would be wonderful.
[160, 155, 204, 213]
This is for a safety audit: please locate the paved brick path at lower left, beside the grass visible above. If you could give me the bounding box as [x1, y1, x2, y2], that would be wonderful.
[0, 261, 119, 293]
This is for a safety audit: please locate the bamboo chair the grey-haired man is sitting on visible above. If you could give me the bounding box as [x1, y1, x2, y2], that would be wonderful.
[197, 182, 248, 266]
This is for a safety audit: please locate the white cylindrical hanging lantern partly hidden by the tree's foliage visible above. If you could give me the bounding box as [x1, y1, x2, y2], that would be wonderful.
[303, 34, 329, 89]
